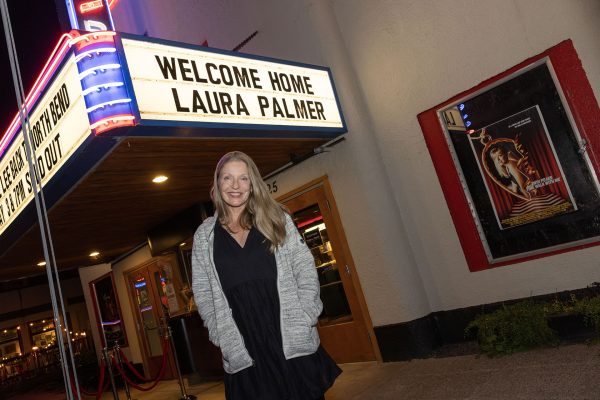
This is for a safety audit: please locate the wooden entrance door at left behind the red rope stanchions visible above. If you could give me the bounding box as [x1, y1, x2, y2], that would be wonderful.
[126, 257, 176, 379]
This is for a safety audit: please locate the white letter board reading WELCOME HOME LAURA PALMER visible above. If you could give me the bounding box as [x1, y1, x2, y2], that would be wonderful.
[122, 38, 345, 130]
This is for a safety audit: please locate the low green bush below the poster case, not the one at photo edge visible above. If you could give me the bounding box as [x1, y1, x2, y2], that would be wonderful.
[466, 300, 559, 356]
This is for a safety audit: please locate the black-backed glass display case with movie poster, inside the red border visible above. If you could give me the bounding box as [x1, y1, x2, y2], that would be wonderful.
[438, 61, 600, 263]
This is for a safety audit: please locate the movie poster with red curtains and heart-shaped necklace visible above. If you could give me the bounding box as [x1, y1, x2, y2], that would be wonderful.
[469, 105, 577, 229]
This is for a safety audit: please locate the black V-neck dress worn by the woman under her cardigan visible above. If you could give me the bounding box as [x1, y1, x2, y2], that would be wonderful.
[213, 222, 342, 400]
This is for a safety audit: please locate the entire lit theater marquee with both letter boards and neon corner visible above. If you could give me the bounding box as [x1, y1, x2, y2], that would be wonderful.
[0, 29, 346, 242]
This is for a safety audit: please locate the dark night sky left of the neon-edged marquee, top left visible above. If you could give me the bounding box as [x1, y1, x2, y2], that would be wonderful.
[0, 0, 62, 136]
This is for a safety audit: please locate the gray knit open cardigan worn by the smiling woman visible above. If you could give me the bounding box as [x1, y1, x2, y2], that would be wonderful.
[192, 214, 323, 374]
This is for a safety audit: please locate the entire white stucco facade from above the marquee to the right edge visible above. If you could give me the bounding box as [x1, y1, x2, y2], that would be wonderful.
[110, 0, 600, 326]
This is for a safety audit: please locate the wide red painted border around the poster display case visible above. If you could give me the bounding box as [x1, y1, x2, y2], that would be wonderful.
[418, 39, 600, 272]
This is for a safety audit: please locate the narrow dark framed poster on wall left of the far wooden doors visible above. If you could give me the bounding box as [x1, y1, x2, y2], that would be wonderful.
[90, 272, 127, 347]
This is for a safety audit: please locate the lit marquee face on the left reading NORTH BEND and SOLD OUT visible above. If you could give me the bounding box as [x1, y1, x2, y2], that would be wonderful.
[0, 54, 90, 234]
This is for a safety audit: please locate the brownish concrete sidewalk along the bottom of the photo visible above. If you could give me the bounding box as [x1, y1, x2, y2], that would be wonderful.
[5, 344, 600, 400]
